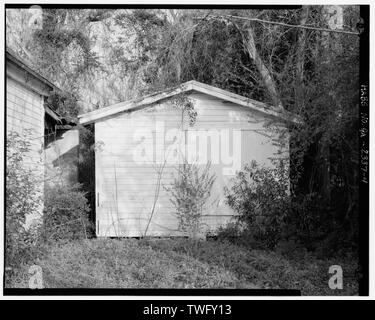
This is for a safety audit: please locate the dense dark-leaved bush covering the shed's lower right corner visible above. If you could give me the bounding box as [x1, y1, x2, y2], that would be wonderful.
[225, 161, 291, 248]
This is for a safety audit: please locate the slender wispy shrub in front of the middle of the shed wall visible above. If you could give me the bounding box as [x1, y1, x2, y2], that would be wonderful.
[168, 162, 215, 238]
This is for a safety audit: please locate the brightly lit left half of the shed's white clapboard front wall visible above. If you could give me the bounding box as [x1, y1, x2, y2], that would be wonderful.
[95, 104, 182, 237]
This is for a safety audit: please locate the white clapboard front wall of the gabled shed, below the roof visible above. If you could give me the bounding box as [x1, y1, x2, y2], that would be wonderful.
[95, 93, 290, 237]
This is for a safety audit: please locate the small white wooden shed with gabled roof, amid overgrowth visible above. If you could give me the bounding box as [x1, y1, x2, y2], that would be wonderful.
[79, 81, 295, 237]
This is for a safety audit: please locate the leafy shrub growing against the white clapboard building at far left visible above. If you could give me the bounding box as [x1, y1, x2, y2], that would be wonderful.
[5, 132, 42, 267]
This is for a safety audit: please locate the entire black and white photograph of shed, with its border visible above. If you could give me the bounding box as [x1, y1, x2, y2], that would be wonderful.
[2, 3, 370, 298]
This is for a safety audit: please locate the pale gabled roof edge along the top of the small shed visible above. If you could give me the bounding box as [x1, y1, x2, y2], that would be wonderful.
[78, 80, 300, 124]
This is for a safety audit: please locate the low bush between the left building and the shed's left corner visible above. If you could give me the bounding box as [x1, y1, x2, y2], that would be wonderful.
[43, 184, 92, 241]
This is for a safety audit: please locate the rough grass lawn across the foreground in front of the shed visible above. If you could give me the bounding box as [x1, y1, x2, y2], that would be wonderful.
[6, 239, 358, 295]
